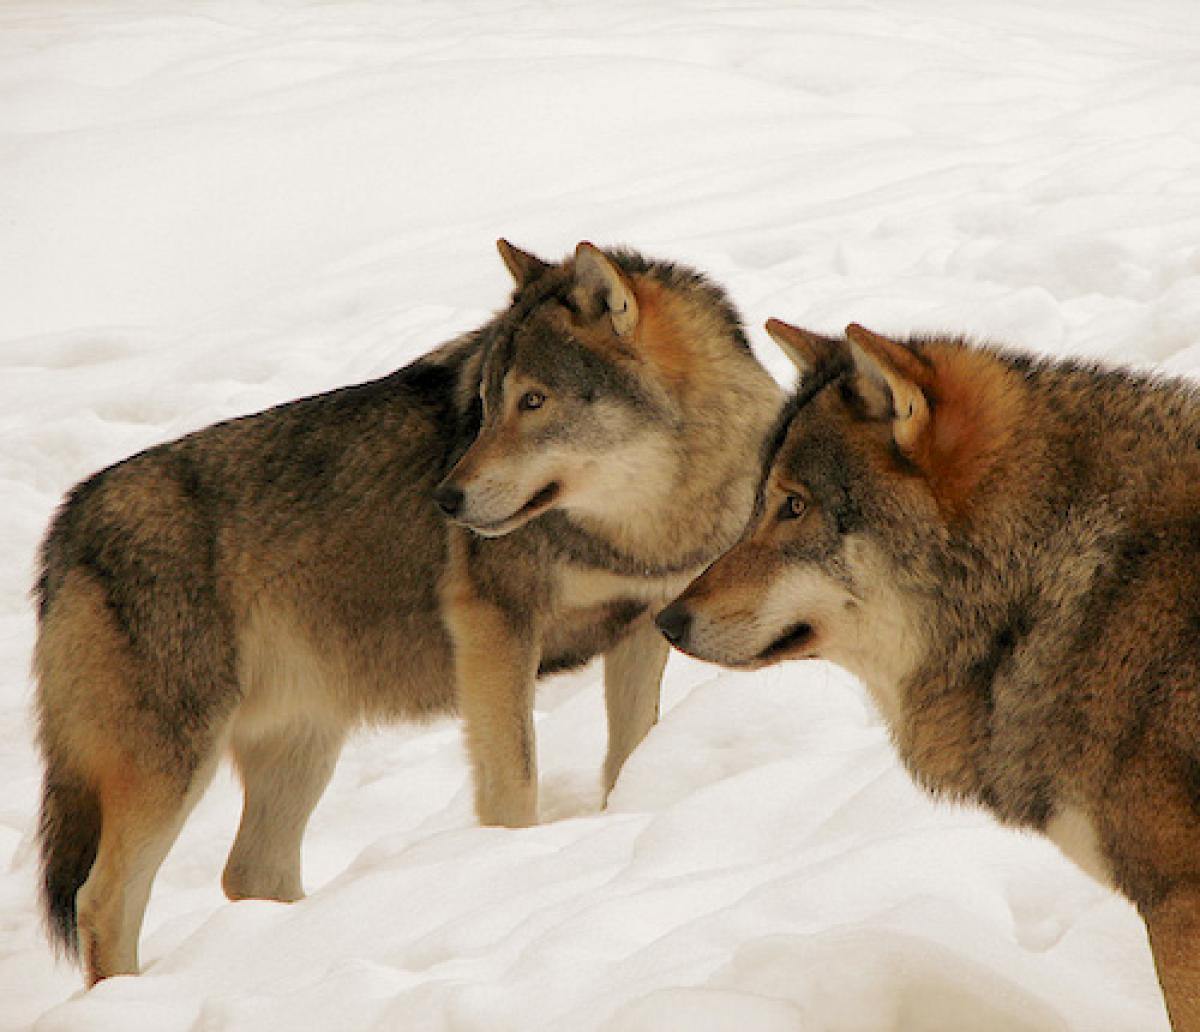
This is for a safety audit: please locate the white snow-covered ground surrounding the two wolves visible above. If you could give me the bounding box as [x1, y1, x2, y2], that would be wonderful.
[0, 0, 1200, 1032]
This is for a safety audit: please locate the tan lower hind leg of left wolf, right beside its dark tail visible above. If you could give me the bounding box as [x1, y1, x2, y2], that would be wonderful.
[76, 749, 220, 985]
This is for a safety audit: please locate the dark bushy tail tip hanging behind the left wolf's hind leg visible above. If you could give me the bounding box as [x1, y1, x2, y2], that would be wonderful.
[37, 762, 100, 959]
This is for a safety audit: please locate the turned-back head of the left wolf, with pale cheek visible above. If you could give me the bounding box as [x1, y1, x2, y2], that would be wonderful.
[434, 241, 764, 536]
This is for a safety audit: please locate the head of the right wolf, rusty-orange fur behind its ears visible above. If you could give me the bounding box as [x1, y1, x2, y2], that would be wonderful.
[658, 320, 1020, 684]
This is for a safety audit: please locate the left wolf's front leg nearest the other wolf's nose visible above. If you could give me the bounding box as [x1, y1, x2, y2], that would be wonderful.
[604, 619, 671, 803]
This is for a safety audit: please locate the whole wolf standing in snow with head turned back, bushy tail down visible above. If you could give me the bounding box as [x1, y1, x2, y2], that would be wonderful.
[34, 240, 782, 984]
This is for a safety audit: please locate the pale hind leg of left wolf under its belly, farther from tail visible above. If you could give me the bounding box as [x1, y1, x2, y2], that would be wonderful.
[221, 724, 343, 902]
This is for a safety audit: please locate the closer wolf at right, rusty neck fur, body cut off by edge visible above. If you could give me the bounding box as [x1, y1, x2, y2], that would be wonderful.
[656, 320, 1200, 1032]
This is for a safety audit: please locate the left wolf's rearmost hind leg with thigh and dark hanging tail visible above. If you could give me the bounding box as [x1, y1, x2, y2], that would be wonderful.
[34, 569, 235, 984]
